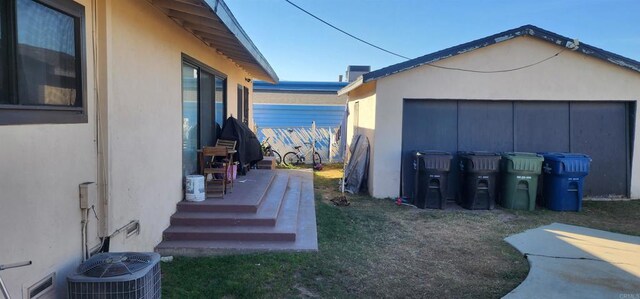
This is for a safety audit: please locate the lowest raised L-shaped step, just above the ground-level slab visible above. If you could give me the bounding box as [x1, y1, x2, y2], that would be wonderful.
[158, 177, 302, 243]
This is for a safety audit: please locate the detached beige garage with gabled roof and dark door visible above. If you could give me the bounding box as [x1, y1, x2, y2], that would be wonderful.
[340, 25, 640, 198]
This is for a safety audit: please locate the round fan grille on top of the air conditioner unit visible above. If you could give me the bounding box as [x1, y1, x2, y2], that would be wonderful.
[78, 252, 153, 277]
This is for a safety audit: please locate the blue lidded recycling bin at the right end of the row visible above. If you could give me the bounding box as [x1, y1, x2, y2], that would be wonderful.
[542, 153, 591, 212]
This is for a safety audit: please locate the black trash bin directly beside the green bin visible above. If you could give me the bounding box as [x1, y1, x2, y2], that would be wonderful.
[458, 152, 500, 210]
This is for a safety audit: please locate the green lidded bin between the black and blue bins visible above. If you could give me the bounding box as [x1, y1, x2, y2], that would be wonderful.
[498, 153, 544, 211]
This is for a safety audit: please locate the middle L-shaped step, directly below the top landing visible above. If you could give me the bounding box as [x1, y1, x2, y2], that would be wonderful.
[171, 174, 289, 226]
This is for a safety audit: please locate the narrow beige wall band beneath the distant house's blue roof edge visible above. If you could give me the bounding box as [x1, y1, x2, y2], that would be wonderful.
[253, 91, 347, 105]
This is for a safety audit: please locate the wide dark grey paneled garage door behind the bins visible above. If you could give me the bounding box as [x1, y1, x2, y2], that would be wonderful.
[401, 99, 635, 199]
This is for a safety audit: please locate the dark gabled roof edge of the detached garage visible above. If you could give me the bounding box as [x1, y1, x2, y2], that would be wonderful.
[339, 25, 640, 94]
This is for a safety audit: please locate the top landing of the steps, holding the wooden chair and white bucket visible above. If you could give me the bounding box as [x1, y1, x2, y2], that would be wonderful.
[177, 170, 278, 213]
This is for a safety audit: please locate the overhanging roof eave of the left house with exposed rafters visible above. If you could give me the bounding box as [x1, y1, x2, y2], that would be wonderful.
[148, 0, 279, 83]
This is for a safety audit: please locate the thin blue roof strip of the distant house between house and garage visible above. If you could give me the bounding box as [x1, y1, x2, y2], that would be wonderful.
[253, 81, 347, 94]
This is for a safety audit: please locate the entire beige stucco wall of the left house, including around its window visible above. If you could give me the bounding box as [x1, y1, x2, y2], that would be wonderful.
[0, 0, 260, 298]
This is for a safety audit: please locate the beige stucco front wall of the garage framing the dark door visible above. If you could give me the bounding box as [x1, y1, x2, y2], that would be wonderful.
[358, 37, 640, 197]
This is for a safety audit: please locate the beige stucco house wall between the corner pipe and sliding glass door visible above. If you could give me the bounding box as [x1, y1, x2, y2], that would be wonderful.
[108, 0, 253, 251]
